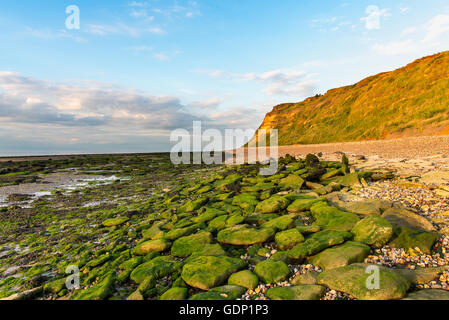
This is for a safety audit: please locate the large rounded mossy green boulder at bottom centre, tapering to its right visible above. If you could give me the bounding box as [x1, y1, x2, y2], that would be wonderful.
[181, 256, 246, 290]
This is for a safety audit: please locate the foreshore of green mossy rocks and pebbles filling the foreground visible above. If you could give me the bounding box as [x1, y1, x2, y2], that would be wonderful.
[0, 154, 449, 300]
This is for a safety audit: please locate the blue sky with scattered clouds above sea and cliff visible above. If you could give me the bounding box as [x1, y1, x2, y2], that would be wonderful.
[0, 0, 449, 156]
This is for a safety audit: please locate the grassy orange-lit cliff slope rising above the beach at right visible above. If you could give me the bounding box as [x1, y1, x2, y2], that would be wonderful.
[252, 52, 449, 145]
